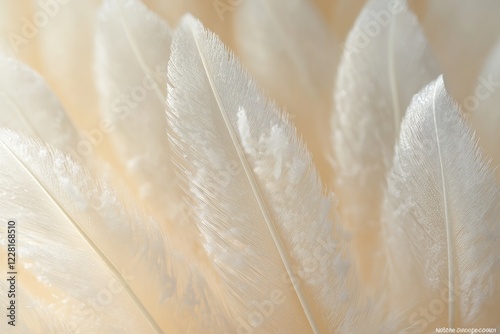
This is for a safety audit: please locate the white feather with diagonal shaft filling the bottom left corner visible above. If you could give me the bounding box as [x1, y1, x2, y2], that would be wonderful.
[0, 130, 229, 333]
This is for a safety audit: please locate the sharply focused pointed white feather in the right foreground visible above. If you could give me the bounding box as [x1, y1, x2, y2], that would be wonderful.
[384, 76, 500, 333]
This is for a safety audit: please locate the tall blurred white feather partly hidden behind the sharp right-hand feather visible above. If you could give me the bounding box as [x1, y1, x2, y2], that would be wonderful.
[332, 0, 437, 286]
